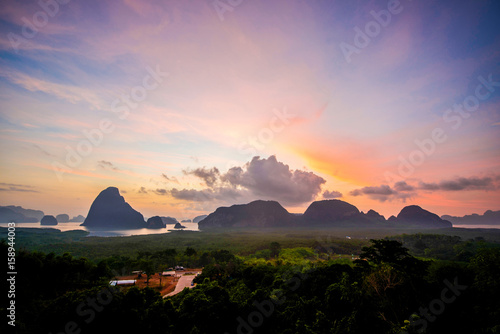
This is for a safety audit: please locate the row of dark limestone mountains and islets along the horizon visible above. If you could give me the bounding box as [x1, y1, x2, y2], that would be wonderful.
[0, 187, 500, 230]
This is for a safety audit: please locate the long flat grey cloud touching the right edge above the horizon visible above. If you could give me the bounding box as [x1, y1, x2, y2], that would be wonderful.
[419, 177, 498, 191]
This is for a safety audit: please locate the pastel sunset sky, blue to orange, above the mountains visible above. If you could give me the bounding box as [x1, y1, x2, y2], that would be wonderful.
[0, 0, 500, 219]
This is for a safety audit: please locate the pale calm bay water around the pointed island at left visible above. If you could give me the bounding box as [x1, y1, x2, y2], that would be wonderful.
[0, 222, 199, 237]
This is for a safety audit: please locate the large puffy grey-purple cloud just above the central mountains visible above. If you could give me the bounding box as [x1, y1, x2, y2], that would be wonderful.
[170, 156, 326, 205]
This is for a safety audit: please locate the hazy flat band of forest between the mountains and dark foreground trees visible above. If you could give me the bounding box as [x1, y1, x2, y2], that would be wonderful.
[0, 227, 500, 262]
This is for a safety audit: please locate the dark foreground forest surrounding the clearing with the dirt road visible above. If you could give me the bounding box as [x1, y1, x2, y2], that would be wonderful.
[0, 232, 500, 334]
